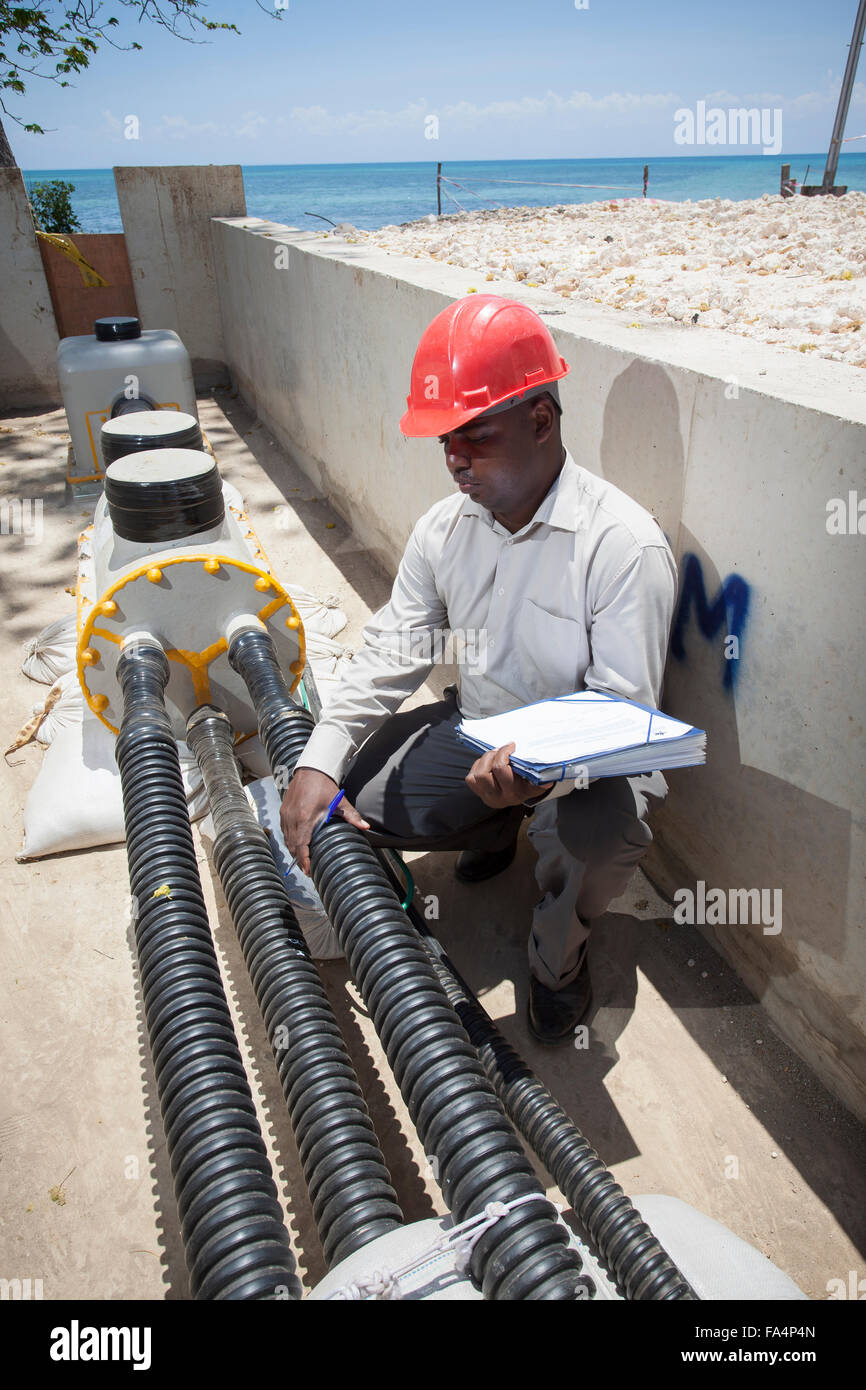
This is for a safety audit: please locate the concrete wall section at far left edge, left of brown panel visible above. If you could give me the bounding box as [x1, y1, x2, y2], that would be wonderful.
[0, 168, 60, 410]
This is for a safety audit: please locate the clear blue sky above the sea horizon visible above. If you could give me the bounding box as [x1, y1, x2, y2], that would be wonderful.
[4, 0, 866, 170]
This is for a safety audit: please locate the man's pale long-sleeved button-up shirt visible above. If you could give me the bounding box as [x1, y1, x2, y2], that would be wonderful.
[297, 452, 677, 796]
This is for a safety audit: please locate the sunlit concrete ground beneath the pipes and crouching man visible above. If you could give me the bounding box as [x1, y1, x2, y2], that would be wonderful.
[0, 392, 866, 1300]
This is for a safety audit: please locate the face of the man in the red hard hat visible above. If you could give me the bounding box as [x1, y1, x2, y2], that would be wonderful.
[439, 402, 553, 516]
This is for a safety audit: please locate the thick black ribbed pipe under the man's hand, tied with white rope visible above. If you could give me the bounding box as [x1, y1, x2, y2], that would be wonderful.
[228, 630, 595, 1300]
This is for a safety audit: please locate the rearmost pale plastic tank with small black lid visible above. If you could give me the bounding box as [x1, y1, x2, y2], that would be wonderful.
[57, 314, 199, 484]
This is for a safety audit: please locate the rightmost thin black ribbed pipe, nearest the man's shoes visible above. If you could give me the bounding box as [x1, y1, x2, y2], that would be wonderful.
[383, 867, 698, 1301]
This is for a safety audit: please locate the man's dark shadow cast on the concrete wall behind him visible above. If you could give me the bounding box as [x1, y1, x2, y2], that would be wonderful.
[601, 361, 866, 1104]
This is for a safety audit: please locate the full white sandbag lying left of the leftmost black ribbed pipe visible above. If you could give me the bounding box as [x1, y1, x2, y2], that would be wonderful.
[15, 710, 207, 860]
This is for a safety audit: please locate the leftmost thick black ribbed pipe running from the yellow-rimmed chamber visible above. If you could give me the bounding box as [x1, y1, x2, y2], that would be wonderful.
[115, 639, 302, 1300]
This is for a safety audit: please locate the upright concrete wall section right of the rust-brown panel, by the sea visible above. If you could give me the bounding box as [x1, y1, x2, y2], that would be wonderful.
[114, 164, 246, 386]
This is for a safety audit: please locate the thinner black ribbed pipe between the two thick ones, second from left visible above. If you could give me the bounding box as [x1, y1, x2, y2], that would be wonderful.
[186, 705, 403, 1265]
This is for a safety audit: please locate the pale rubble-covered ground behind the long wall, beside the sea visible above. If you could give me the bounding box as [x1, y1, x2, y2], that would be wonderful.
[350, 192, 866, 367]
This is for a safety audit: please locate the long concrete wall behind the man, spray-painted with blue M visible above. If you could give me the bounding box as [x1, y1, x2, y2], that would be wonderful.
[214, 218, 866, 1116]
